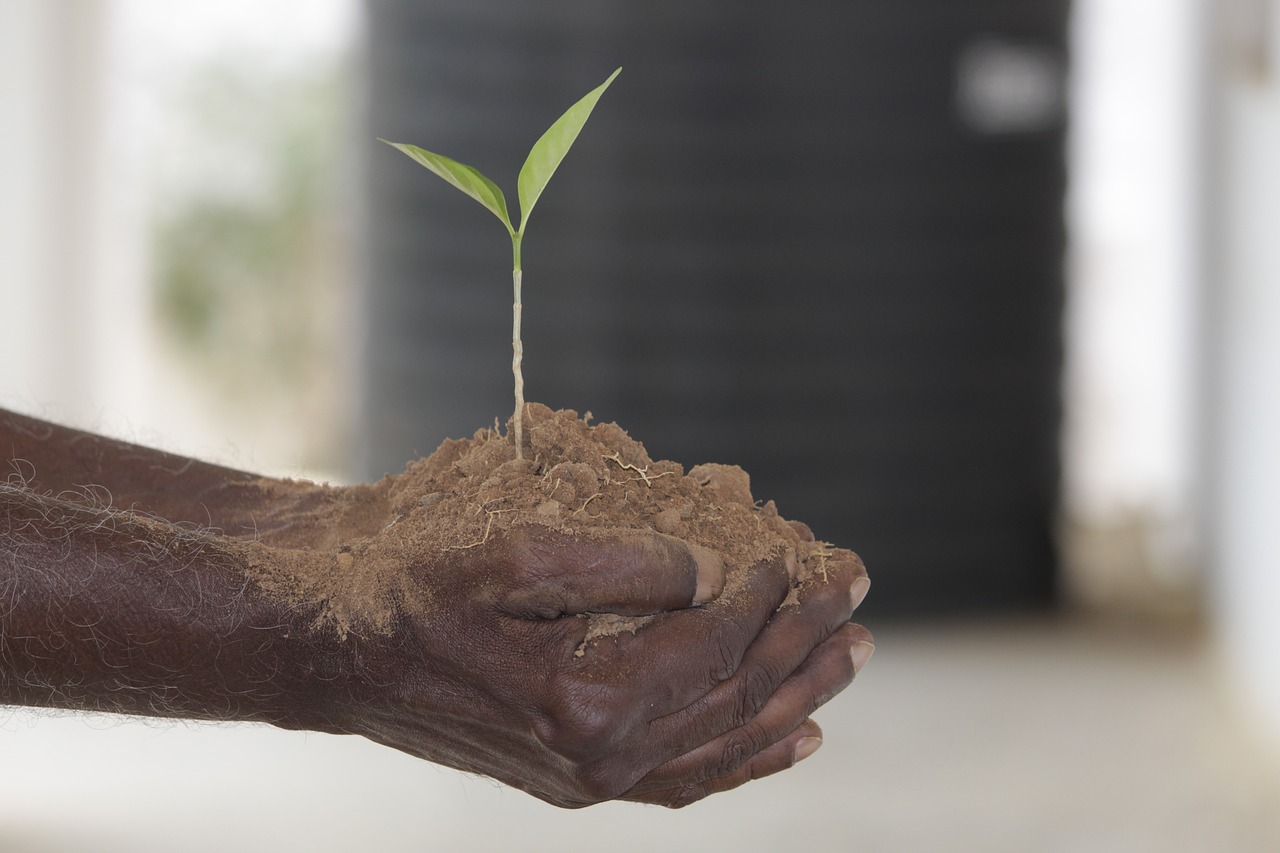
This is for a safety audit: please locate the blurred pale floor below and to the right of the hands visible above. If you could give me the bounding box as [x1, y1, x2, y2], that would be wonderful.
[0, 620, 1280, 853]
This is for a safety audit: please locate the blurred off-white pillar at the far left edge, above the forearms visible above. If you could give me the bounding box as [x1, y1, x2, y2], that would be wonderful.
[0, 0, 104, 416]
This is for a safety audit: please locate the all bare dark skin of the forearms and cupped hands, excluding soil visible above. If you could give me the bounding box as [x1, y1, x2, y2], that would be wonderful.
[0, 411, 872, 807]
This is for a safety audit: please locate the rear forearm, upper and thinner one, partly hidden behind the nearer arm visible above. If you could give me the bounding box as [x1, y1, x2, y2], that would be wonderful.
[0, 410, 280, 535]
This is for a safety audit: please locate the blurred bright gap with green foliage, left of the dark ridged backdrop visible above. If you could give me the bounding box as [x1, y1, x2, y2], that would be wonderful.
[151, 48, 351, 466]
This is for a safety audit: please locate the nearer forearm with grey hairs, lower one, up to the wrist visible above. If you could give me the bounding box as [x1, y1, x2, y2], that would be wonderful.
[0, 485, 347, 730]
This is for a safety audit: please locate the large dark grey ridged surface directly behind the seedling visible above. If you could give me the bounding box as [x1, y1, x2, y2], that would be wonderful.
[361, 0, 1069, 612]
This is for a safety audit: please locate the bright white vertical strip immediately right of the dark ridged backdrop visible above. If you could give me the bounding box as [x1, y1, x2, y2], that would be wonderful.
[1062, 0, 1203, 612]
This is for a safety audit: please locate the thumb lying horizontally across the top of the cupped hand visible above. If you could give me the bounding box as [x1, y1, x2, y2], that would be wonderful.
[504, 529, 724, 619]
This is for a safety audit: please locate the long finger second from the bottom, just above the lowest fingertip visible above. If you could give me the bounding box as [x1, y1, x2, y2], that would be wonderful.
[636, 625, 876, 792]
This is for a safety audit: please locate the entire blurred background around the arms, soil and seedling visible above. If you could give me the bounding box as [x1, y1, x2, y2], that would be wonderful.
[0, 0, 1280, 852]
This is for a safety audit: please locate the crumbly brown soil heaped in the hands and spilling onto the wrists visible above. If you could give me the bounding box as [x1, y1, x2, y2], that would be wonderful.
[240, 403, 856, 638]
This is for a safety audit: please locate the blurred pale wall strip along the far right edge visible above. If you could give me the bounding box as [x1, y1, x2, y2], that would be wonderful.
[1204, 0, 1280, 748]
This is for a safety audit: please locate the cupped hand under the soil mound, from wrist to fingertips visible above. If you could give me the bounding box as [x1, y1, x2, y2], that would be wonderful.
[329, 528, 870, 807]
